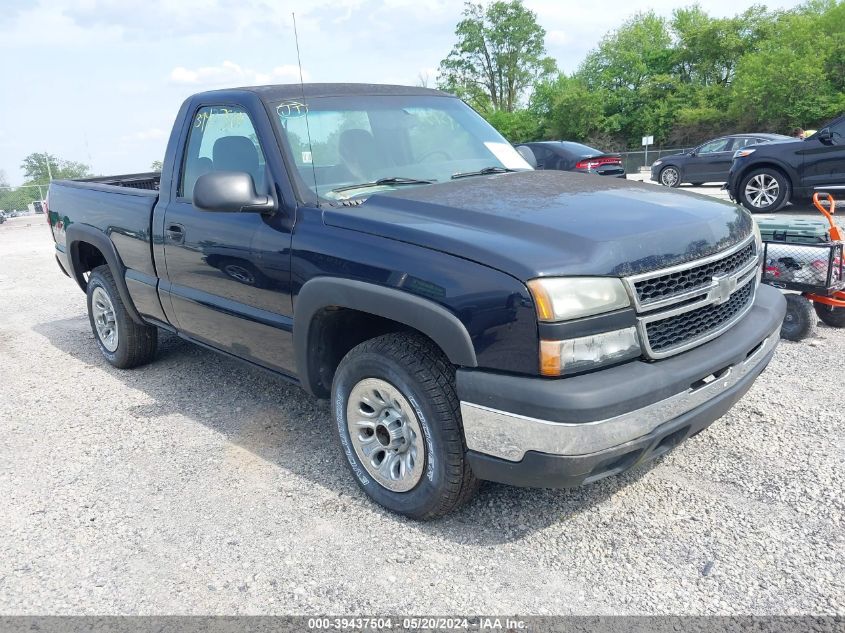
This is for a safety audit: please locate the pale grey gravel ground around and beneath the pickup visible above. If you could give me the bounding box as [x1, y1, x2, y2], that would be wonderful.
[0, 218, 845, 615]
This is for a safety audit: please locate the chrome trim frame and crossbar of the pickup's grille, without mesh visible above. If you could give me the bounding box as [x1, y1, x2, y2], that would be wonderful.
[622, 233, 761, 360]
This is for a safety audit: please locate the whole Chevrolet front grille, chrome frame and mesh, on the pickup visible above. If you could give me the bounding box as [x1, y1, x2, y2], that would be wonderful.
[624, 236, 760, 359]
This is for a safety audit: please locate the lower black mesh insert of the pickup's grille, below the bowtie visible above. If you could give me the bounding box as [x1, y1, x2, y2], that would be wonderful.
[646, 278, 754, 352]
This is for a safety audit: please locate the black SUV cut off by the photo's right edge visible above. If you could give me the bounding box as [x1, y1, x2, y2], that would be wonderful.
[727, 115, 845, 213]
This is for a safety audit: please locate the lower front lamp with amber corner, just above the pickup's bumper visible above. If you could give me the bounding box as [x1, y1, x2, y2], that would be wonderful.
[540, 327, 642, 376]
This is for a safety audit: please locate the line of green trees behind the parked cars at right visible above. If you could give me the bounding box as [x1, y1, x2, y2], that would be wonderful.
[438, 0, 845, 150]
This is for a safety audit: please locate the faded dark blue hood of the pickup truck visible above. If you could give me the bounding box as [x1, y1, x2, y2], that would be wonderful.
[323, 171, 753, 281]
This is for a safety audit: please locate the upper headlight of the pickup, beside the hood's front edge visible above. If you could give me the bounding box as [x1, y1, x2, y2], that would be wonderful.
[528, 277, 631, 323]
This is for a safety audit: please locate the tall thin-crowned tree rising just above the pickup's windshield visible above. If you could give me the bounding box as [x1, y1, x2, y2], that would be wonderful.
[438, 0, 555, 112]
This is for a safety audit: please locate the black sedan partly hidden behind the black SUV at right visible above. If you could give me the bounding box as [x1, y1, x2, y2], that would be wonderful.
[651, 132, 790, 187]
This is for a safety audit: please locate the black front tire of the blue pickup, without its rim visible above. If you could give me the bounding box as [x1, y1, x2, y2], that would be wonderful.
[332, 333, 479, 520]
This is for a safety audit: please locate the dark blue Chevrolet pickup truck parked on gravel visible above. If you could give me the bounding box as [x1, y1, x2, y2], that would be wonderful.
[48, 84, 785, 519]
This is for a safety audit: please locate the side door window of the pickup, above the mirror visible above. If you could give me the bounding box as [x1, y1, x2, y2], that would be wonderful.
[177, 106, 266, 200]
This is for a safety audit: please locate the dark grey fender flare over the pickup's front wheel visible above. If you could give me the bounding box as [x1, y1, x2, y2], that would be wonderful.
[293, 277, 478, 394]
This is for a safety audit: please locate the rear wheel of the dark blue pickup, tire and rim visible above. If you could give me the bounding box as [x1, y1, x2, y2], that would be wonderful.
[88, 266, 158, 369]
